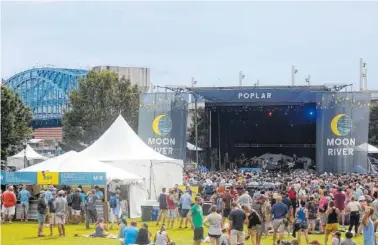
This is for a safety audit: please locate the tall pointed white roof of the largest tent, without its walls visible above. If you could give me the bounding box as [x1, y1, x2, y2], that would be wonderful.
[81, 115, 177, 161]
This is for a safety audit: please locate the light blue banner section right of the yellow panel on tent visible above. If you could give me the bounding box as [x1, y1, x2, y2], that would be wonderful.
[59, 173, 106, 185]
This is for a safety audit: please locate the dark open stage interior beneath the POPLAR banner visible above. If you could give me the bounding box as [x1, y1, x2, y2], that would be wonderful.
[206, 103, 316, 168]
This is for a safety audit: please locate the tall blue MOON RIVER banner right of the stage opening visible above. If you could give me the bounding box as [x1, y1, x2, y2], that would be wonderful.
[316, 92, 370, 173]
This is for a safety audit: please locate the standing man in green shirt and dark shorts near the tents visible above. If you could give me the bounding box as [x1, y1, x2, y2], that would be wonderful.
[188, 196, 204, 245]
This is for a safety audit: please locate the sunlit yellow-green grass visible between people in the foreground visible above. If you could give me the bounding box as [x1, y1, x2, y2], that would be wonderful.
[0, 222, 372, 245]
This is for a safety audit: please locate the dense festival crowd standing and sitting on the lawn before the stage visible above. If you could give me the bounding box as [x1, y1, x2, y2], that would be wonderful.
[2, 170, 378, 245]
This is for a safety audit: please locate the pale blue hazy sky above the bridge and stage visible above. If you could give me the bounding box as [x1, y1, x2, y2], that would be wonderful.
[1, 1, 378, 90]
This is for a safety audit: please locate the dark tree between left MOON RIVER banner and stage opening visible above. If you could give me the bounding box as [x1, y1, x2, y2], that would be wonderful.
[188, 107, 207, 149]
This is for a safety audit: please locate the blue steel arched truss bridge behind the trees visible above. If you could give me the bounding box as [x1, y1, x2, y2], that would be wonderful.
[4, 68, 88, 128]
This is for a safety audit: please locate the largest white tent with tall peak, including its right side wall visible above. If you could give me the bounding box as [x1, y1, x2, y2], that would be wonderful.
[80, 115, 184, 198]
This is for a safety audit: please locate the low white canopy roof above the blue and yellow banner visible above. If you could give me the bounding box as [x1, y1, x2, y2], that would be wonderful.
[20, 151, 142, 182]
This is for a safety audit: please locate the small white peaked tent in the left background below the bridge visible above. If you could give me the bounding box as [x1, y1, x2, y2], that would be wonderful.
[7, 145, 48, 169]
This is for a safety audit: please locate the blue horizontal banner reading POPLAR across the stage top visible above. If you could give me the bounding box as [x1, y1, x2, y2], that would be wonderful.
[193, 87, 324, 104]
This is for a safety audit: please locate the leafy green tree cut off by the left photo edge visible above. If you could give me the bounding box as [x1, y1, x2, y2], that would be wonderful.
[1, 85, 33, 160]
